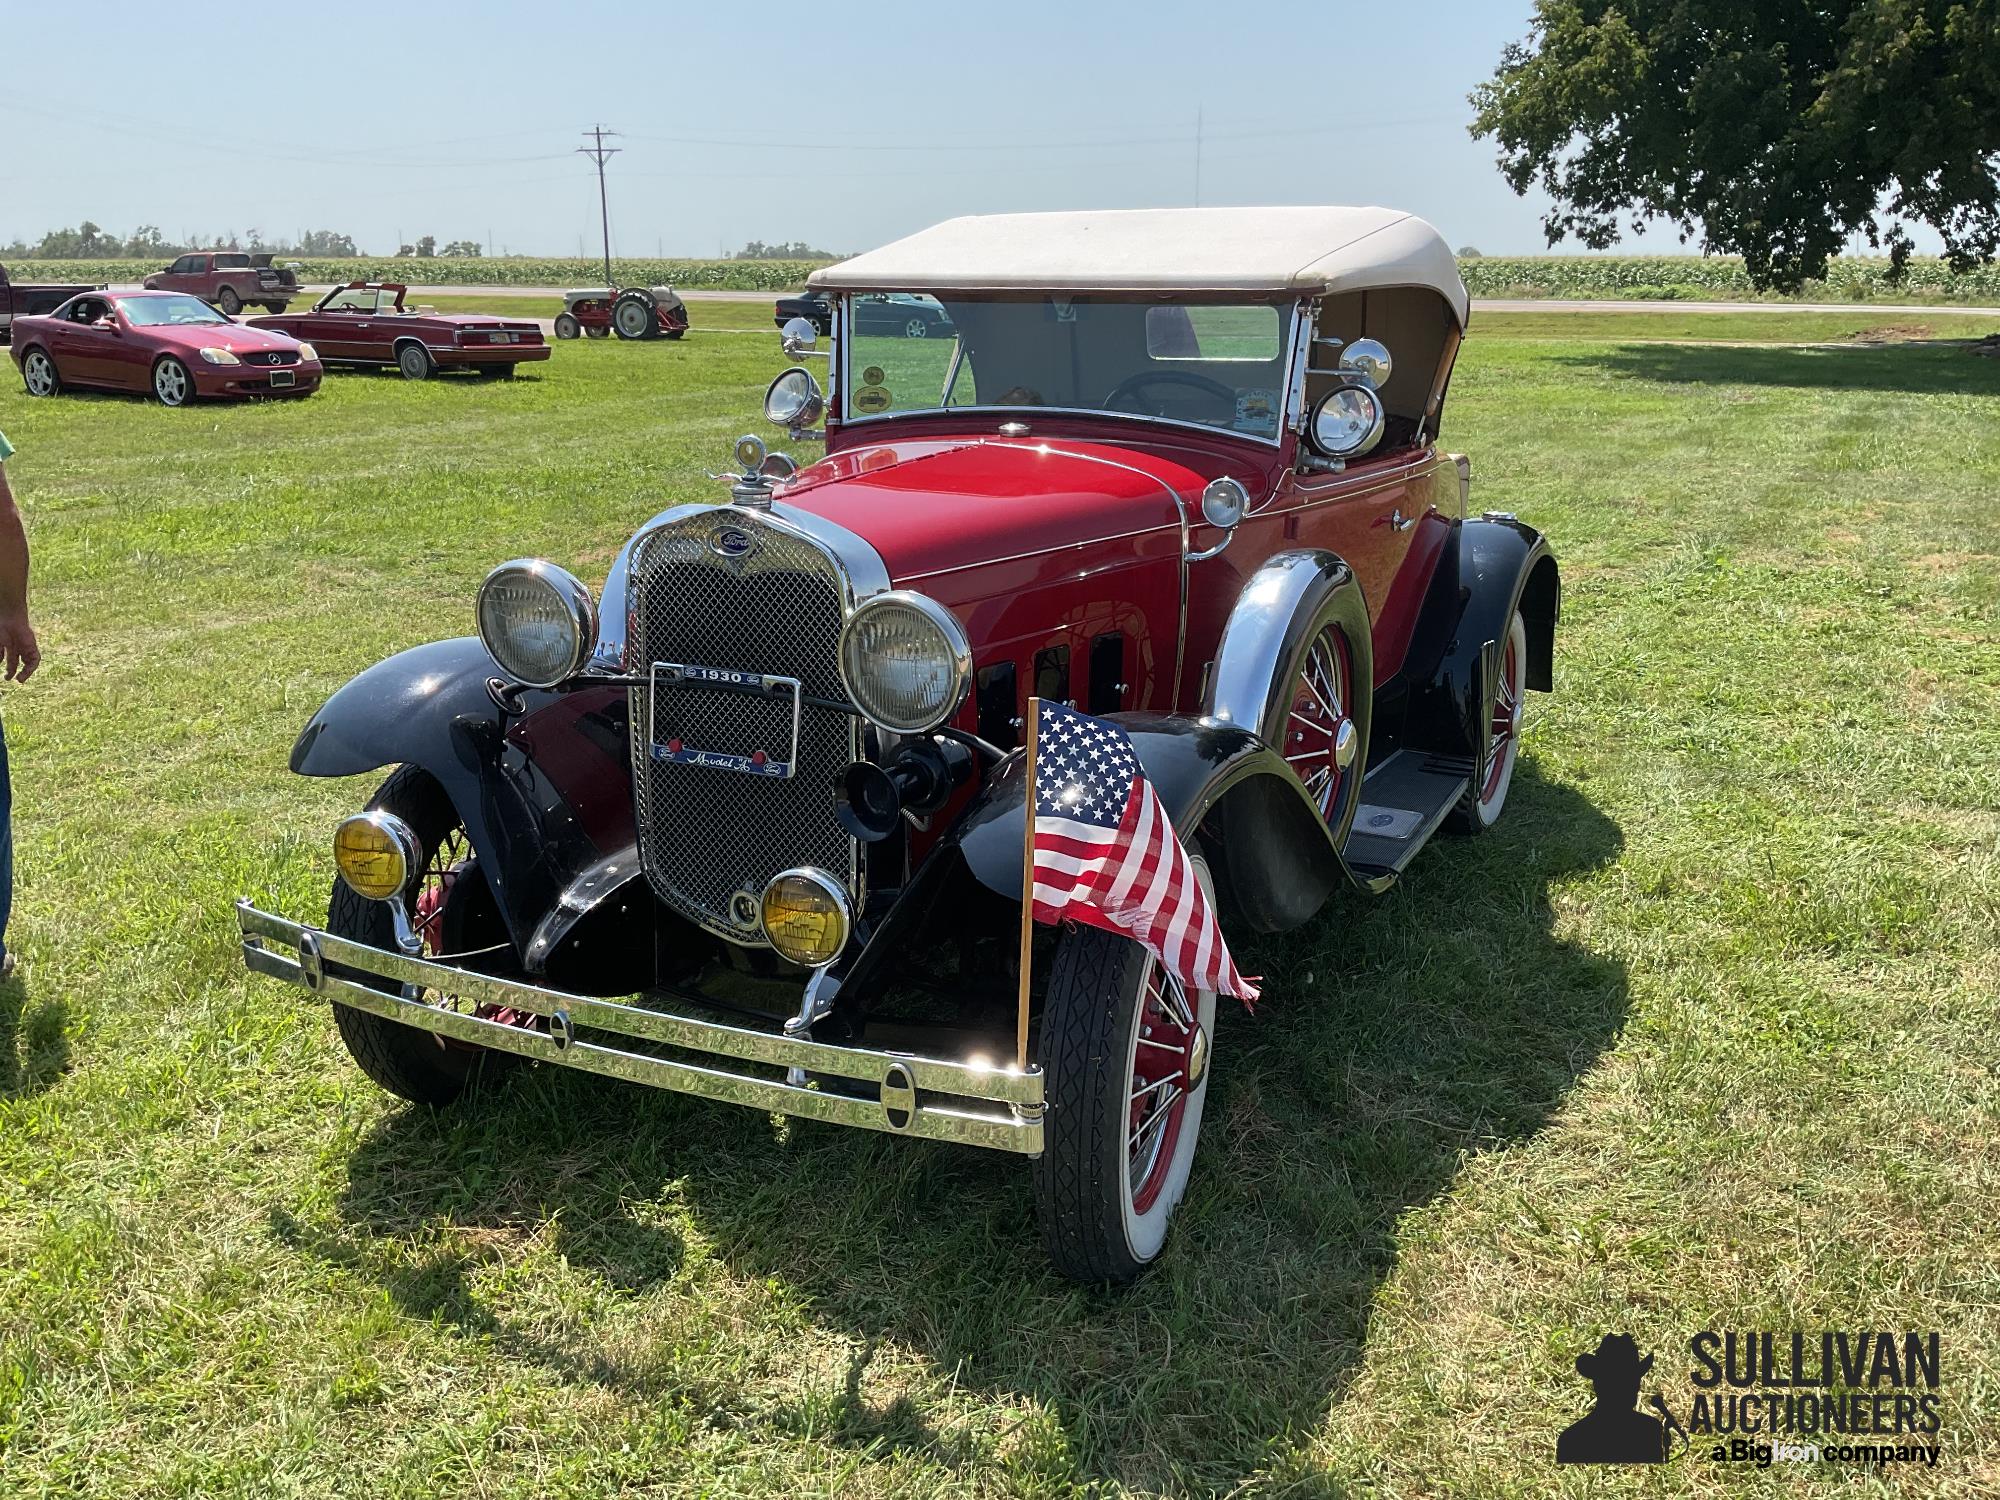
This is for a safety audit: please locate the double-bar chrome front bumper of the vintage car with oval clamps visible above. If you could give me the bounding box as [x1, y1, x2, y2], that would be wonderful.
[236, 900, 1042, 1156]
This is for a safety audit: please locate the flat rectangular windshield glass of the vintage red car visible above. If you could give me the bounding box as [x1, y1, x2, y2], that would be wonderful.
[846, 292, 1290, 440]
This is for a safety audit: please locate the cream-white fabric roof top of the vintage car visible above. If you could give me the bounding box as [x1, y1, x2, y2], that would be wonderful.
[808, 208, 1470, 326]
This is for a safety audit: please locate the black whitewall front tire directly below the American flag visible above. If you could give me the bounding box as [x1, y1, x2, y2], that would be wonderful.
[1034, 862, 1216, 1286]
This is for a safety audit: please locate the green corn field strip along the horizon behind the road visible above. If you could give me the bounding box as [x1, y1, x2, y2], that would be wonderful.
[10, 256, 2000, 304]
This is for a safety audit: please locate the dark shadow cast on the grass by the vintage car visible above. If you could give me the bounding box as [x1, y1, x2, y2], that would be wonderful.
[320, 760, 1626, 1490]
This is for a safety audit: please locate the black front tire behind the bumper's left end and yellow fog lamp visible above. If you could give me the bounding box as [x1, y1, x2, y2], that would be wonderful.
[326, 766, 516, 1104]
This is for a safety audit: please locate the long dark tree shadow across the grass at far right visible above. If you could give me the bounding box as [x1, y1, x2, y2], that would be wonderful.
[1558, 340, 2000, 396]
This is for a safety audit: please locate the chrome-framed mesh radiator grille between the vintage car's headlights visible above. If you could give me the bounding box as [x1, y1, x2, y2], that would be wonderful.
[626, 510, 860, 944]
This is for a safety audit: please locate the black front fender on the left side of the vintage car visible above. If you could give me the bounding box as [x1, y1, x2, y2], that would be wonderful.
[292, 636, 636, 966]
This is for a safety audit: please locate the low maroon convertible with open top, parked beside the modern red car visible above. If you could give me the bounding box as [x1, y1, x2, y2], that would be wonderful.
[250, 282, 548, 380]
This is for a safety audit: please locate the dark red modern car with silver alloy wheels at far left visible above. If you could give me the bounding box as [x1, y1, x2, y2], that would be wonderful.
[14, 292, 324, 406]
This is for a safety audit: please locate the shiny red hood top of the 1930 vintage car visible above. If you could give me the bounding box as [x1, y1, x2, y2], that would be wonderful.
[778, 438, 1202, 592]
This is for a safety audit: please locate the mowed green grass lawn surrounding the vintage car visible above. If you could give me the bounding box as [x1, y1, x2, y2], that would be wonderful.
[0, 304, 2000, 1500]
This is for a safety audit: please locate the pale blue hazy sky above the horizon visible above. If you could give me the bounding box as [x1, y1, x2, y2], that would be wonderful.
[0, 0, 1920, 256]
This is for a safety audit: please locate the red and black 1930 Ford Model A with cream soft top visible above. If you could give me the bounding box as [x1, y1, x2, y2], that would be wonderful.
[238, 208, 1558, 1280]
